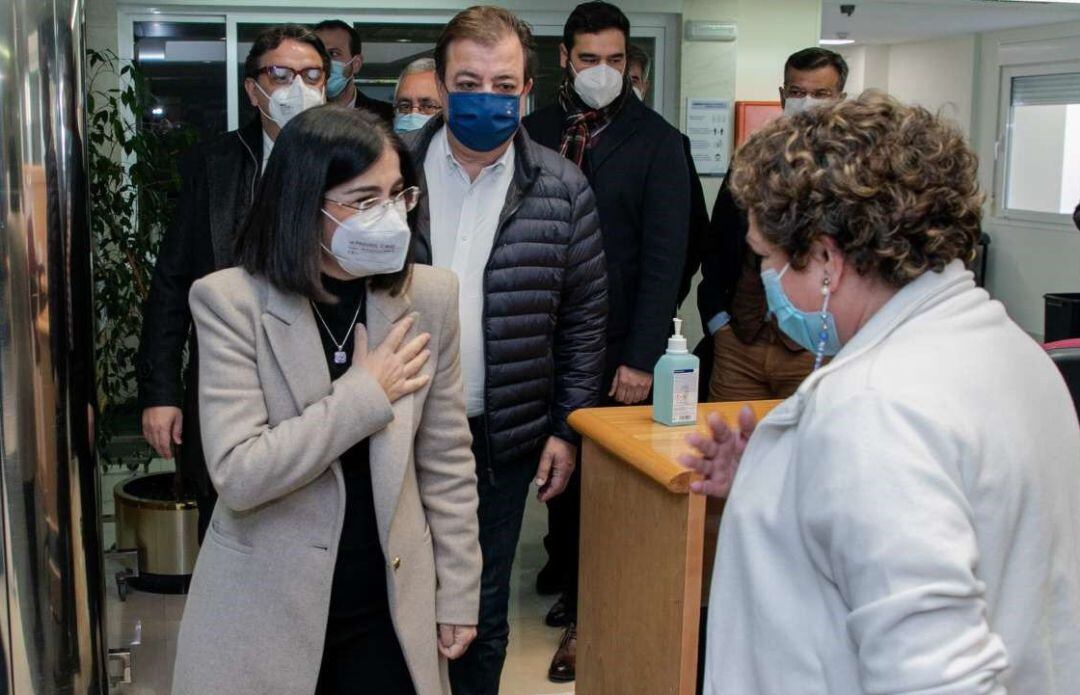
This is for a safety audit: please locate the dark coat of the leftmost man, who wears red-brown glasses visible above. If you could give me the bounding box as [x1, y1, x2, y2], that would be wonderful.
[137, 118, 262, 493]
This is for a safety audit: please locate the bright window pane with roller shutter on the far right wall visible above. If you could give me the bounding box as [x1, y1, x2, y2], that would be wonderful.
[1005, 73, 1080, 214]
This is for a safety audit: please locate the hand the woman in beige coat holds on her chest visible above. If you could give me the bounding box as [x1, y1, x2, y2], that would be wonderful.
[352, 316, 431, 403]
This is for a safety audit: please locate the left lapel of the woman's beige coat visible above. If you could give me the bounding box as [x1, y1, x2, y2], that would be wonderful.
[262, 285, 330, 413]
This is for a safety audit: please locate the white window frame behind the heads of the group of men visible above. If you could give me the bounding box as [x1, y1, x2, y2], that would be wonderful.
[117, 5, 679, 131]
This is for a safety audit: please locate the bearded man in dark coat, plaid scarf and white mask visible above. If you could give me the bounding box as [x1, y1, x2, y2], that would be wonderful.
[524, 2, 690, 681]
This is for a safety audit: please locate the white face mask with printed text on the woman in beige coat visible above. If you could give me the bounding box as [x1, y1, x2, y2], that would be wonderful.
[323, 208, 413, 277]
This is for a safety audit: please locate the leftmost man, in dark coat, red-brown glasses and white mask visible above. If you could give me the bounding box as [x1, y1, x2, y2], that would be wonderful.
[136, 25, 329, 541]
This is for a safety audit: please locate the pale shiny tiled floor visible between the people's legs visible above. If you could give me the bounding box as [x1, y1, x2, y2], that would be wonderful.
[102, 466, 573, 695]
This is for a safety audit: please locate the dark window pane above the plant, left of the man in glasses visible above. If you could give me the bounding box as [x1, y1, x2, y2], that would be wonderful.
[134, 22, 228, 139]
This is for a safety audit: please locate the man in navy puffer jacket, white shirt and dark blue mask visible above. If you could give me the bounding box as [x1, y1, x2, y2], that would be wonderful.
[406, 6, 607, 695]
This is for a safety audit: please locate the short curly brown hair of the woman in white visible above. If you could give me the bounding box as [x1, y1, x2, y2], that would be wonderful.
[731, 92, 983, 287]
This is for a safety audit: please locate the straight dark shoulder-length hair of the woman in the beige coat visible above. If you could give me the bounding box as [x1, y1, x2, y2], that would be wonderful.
[235, 105, 417, 301]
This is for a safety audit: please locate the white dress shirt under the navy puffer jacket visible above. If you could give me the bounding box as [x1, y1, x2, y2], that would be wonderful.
[423, 126, 515, 418]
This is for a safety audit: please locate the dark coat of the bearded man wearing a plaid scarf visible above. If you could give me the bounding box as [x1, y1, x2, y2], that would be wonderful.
[524, 98, 690, 374]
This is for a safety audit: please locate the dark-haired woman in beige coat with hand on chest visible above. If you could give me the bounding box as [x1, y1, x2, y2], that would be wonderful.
[173, 107, 481, 695]
